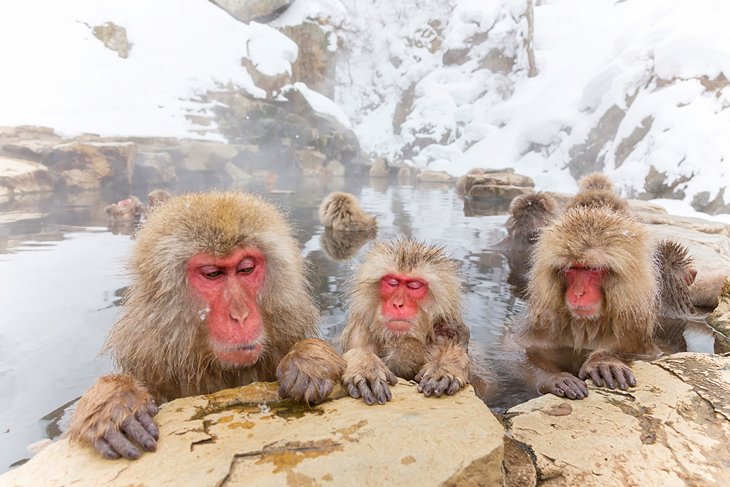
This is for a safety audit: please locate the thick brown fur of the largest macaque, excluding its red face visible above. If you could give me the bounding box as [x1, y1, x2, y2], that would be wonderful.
[71, 192, 344, 456]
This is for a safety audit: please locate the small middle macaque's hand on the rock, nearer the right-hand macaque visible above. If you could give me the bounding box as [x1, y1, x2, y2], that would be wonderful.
[415, 344, 469, 396]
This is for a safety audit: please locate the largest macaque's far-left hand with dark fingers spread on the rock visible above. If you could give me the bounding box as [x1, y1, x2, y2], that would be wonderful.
[69, 375, 160, 460]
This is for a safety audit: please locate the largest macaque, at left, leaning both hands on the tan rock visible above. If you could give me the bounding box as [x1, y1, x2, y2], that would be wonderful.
[69, 192, 345, 459]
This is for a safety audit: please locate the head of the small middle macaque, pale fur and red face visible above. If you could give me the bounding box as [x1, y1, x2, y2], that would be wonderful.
[350, 239, 462, 341]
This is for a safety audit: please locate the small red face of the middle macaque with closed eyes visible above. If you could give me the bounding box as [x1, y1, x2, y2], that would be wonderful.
[380, 274, 428, 333]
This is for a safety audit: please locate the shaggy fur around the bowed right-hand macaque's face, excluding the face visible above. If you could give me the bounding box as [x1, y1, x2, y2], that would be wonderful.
[527, 208, 659, 354]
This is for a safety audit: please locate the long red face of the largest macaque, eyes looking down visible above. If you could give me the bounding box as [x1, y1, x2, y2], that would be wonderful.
[187, 247, 266, 366]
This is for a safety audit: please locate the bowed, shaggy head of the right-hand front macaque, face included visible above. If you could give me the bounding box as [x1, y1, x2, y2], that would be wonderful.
[528, 207, 657, 320]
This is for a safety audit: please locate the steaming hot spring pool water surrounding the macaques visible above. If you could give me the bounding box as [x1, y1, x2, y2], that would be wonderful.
[0, 174, 534, 472]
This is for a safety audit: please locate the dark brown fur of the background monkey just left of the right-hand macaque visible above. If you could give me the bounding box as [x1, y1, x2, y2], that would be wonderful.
[499, 192, 558, 251]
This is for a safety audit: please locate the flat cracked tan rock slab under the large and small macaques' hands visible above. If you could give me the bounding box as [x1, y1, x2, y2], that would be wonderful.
[0, 381, 503, 487]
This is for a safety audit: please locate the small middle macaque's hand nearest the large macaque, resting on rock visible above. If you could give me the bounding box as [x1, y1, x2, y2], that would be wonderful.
[342, 348, 398, 405]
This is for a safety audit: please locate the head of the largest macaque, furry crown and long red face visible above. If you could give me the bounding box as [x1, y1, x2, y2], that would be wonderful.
[132, 192, 306, 366]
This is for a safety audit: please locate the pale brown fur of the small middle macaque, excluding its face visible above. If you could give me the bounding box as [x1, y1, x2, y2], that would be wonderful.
[342, 239, 469, 402]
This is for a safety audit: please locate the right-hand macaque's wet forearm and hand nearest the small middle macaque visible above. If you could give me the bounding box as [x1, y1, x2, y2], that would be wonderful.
[526, 347, 588, 399]
